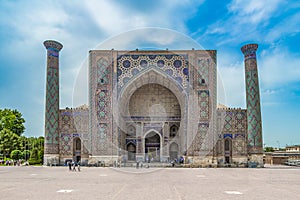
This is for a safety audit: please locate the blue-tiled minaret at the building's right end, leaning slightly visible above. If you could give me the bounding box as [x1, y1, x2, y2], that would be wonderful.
[241, 44, 263, 166]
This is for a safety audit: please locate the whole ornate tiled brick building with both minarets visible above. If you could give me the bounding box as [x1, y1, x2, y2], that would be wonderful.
[44, 40, 263, 166]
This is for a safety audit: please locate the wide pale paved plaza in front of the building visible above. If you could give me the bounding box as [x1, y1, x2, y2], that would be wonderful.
[0, 166, 300, 200]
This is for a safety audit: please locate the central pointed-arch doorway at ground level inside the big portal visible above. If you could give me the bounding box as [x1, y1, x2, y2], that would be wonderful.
[145, 131, 160, 162]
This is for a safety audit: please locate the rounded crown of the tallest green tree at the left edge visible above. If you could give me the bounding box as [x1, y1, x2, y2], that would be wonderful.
[0, 109, 25, 136]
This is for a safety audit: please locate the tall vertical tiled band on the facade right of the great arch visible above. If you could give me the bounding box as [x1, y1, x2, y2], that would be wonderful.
[190, 51, 217, 156]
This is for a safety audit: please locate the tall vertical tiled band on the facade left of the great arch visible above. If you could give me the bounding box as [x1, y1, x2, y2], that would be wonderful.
[89, 51, 115, 155]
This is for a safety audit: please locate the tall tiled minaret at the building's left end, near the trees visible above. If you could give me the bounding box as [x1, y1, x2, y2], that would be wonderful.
[44, 40, 63, 165]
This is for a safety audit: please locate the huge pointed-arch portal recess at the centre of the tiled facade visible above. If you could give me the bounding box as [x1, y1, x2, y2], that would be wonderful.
[117, 69, 187, 162]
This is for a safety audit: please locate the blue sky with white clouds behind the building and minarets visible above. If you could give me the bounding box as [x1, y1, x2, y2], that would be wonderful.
[0, 0, 300, 147]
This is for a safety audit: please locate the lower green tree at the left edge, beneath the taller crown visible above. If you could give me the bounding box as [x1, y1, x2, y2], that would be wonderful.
[0, 128, 20, 157]
